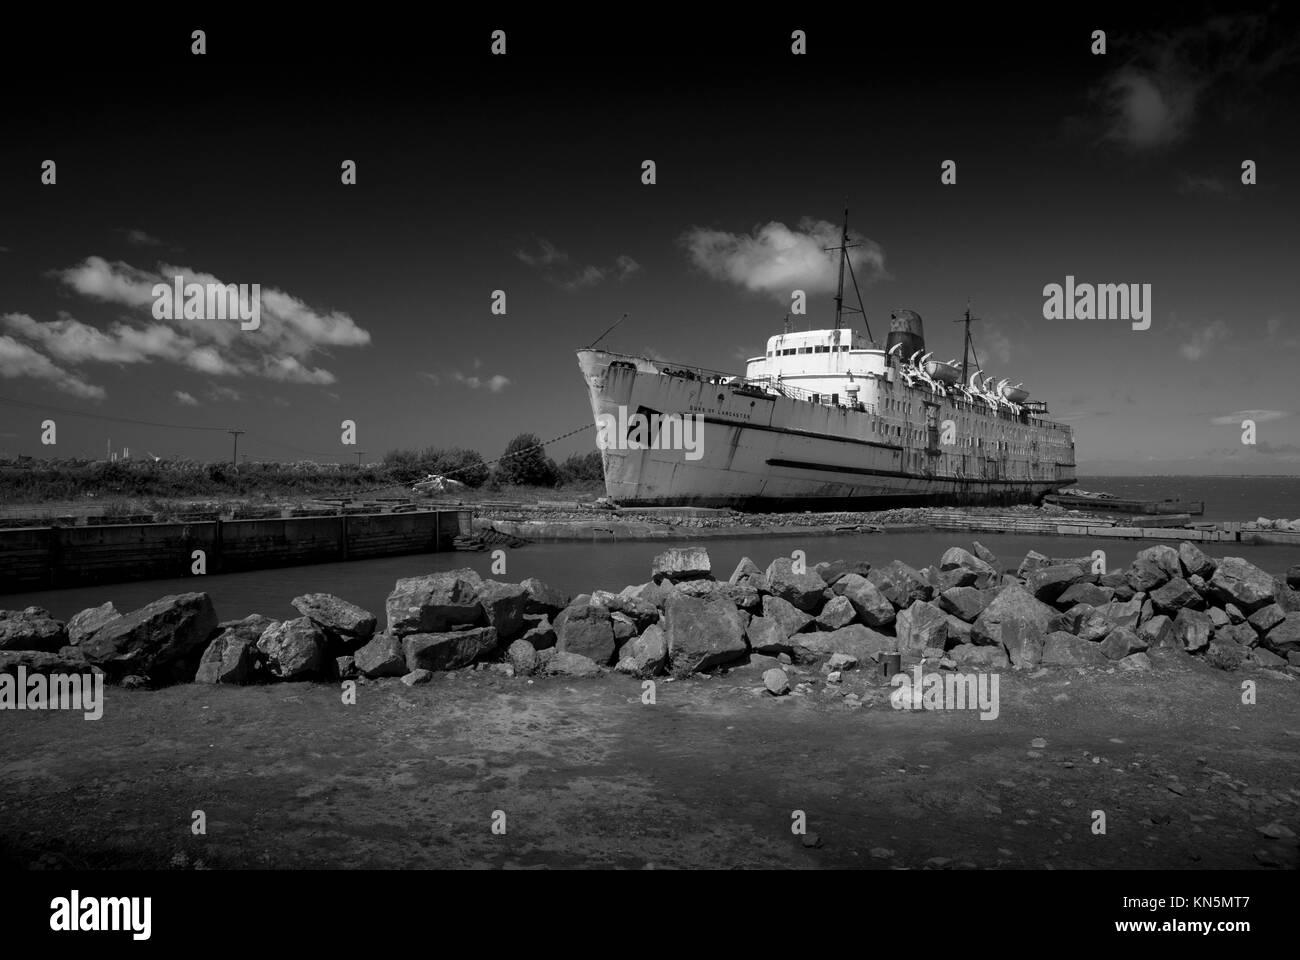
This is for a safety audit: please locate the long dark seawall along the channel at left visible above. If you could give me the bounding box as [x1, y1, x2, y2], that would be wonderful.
[0, 509, 471, 593]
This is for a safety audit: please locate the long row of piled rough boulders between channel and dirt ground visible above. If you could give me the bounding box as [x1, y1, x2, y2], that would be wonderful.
[0, 542, 1300, 696]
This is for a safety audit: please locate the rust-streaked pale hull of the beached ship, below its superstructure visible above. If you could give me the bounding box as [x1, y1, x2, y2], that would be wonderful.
[579, 350, 1075, 511]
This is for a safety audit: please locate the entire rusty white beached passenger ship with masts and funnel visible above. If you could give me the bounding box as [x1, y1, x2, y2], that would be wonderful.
[577, 213, 1075, 510]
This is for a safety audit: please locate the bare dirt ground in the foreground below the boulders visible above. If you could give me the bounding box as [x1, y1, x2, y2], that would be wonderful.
[0, 652, 1300, 869]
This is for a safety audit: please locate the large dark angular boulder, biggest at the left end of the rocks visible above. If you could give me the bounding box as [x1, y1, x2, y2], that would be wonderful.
[79, 593, 217, 686]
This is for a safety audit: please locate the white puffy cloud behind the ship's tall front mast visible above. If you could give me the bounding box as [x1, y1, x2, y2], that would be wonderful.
[680, 217, 885, 303]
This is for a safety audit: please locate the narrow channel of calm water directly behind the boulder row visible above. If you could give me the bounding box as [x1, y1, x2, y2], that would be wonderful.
[10, 522, 1300, 624]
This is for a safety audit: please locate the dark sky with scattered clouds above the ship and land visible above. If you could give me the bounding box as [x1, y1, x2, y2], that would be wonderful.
[0, 4, 1300, 476]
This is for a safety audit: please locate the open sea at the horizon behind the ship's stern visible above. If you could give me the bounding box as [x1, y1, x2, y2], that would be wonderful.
[1078, 476, 1300, 520]
